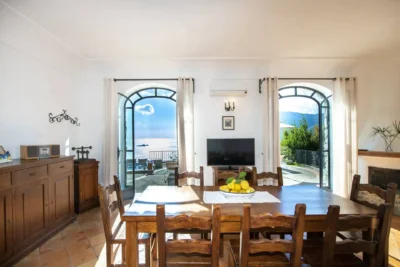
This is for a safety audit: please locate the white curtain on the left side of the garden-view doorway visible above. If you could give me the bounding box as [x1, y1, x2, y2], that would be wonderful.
[262, 77, 280, 172]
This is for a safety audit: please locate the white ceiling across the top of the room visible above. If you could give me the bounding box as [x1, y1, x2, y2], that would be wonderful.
[4, 0, 400, 60]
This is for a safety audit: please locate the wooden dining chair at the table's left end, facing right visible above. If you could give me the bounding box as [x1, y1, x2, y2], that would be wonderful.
[98, 183, 151, 267]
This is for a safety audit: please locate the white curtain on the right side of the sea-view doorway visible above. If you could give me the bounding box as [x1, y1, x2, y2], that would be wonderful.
[176, 78, 194, 172]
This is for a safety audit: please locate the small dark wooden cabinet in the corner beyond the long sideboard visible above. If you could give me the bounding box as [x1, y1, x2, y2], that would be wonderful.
[74, 159, 99, 213]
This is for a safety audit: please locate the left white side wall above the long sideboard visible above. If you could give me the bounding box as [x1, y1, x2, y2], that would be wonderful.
[0, 3, 84, 158]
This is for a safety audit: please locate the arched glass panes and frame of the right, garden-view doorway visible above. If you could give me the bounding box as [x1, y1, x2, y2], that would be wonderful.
[279, 86, 332, 189]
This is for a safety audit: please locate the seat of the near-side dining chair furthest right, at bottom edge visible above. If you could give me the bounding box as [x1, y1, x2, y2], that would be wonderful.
[303, 253, 368, 267]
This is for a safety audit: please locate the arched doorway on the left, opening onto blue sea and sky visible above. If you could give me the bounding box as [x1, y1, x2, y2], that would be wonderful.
[118, 87, 177, 194]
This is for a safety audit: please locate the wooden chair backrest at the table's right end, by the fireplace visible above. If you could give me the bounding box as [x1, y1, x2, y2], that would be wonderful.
[350, 174, 397, 209]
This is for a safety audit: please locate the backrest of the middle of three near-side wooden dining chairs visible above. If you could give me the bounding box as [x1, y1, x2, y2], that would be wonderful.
[240, 204, 306, 267]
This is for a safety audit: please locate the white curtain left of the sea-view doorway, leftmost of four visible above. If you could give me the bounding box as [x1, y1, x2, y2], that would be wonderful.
[102, 79, 118, 185]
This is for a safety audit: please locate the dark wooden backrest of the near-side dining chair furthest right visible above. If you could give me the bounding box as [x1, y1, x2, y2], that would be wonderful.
[322, 203, 393, 267]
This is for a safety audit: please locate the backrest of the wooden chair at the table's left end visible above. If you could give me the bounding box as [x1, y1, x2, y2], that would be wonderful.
[98, 184, 123, 242]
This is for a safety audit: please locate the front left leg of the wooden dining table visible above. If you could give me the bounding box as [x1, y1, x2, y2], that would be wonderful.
[126, 222, 139, 267]
